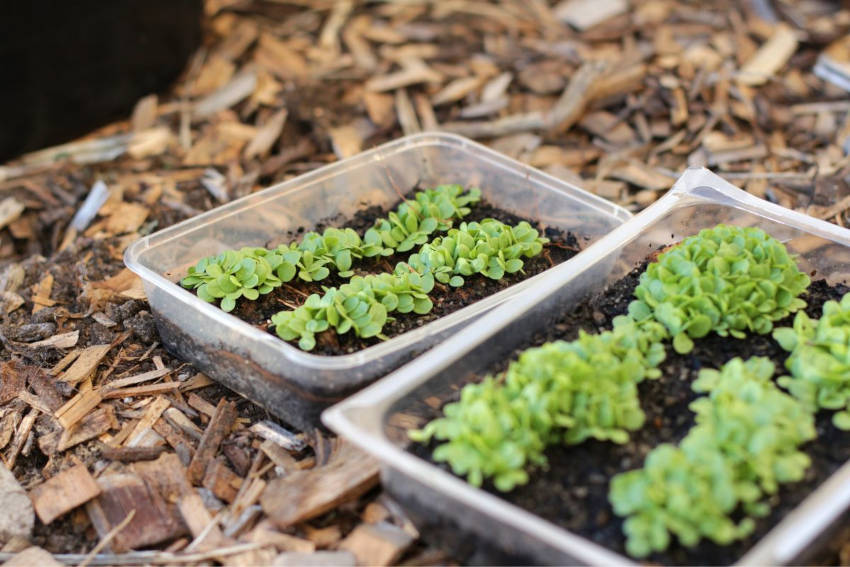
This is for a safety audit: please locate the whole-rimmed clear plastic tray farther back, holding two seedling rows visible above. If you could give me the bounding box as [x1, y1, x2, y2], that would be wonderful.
[124, 133, 631, 428]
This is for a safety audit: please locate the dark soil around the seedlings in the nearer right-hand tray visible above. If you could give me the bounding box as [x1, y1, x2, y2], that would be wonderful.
[408, 267, 850, 565]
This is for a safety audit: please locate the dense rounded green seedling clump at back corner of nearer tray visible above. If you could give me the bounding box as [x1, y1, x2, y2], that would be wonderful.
[629, 225, 809, 353]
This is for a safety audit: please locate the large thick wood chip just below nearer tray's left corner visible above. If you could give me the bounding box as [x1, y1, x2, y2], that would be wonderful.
[261, 441, 378, 528]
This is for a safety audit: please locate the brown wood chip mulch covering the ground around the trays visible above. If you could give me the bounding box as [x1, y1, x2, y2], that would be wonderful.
[0, 0, 850, 565]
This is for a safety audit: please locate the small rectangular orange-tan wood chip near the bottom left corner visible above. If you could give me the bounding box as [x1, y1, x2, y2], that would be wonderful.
[30, 465, 100, 524]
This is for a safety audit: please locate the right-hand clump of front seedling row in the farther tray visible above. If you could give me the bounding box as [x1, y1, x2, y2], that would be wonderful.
[408, 219, 549, 287]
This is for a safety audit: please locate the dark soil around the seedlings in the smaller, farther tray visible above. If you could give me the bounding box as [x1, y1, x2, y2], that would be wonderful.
[233, 201, 580, 355]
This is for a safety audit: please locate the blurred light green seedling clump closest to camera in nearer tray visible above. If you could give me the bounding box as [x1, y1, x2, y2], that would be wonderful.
[609, 358, 815, 557]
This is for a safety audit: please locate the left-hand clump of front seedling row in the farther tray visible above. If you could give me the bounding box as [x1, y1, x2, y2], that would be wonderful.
[272, 271, 434, 350]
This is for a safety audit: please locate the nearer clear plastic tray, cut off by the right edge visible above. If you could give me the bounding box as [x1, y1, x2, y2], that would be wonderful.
[323, 169, 850, 565]
